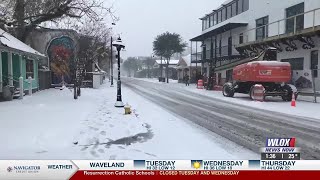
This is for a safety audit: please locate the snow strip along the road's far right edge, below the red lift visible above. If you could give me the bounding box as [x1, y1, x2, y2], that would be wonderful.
[136, 77, 320, 121]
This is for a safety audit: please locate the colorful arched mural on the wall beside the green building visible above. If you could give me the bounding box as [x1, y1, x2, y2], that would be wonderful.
[47, 36, 75, 84]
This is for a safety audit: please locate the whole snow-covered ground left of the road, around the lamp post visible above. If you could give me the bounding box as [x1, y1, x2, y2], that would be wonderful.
[0, 81, 259, 159]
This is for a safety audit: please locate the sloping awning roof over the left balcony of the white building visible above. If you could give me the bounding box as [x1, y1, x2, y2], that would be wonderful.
[190, 23, 248, 41]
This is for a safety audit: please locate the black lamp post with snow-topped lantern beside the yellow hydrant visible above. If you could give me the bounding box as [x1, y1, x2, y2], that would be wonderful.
[112, 37, 125, 107]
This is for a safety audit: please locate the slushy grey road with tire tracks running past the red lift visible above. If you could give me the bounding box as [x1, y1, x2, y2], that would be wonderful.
[124, 78, 320, 159]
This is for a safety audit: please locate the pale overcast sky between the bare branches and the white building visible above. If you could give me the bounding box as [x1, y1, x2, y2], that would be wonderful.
[113, 0, 225, 56]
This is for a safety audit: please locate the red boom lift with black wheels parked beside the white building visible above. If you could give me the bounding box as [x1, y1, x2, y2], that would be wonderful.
[223, 48, 298, 101]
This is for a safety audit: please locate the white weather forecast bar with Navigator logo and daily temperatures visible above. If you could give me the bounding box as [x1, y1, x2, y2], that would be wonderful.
[0, 160, 320, 179]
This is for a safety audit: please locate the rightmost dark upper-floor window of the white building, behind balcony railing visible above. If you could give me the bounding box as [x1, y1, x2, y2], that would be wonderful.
[286, 3, 304, 33]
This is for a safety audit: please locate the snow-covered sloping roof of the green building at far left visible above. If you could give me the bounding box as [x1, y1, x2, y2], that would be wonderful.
[0, 28, 45, 57]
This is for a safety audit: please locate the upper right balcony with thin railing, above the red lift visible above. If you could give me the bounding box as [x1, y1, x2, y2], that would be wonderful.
[235, 8, 320, 56]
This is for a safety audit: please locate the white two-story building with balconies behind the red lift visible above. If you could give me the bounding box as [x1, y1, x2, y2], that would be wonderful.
[191, 0, 320, 90]
